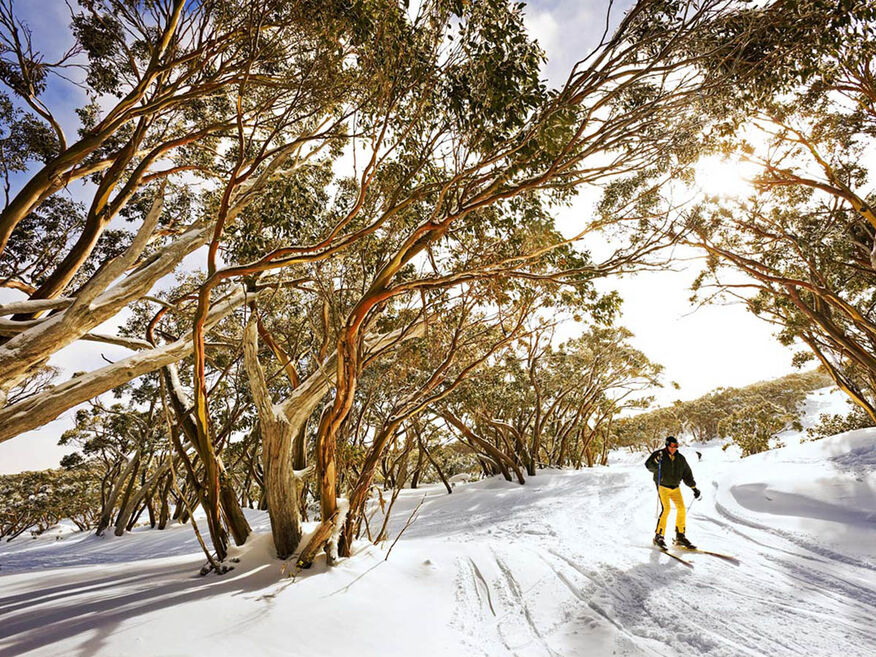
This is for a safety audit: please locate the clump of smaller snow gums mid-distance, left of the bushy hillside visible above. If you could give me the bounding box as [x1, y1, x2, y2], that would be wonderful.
[441, 325, 662, 478]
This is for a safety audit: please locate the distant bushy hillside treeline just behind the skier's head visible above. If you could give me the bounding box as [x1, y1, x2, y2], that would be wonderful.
[615, 369, 833, 456]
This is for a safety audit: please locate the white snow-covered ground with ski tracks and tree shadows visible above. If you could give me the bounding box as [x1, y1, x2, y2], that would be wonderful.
[0, 386, 876, 657]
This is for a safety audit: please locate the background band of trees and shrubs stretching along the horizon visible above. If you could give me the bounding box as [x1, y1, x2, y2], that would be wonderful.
[0, 366, 869, 540]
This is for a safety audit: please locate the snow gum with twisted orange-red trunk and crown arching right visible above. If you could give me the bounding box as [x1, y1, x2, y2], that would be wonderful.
[282, 2, 740, 564]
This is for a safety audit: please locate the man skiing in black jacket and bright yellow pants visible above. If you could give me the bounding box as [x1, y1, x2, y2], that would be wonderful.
[645, 436, 700, 550]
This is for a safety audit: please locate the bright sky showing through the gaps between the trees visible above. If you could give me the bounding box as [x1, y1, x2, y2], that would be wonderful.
[0, 0, 794, 474]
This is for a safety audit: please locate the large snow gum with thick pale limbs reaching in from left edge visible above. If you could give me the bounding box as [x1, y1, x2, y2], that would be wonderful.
[0, 0, 366, 440]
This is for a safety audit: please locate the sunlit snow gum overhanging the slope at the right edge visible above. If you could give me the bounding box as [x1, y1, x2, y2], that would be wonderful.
[690, 0, 876, 421]
